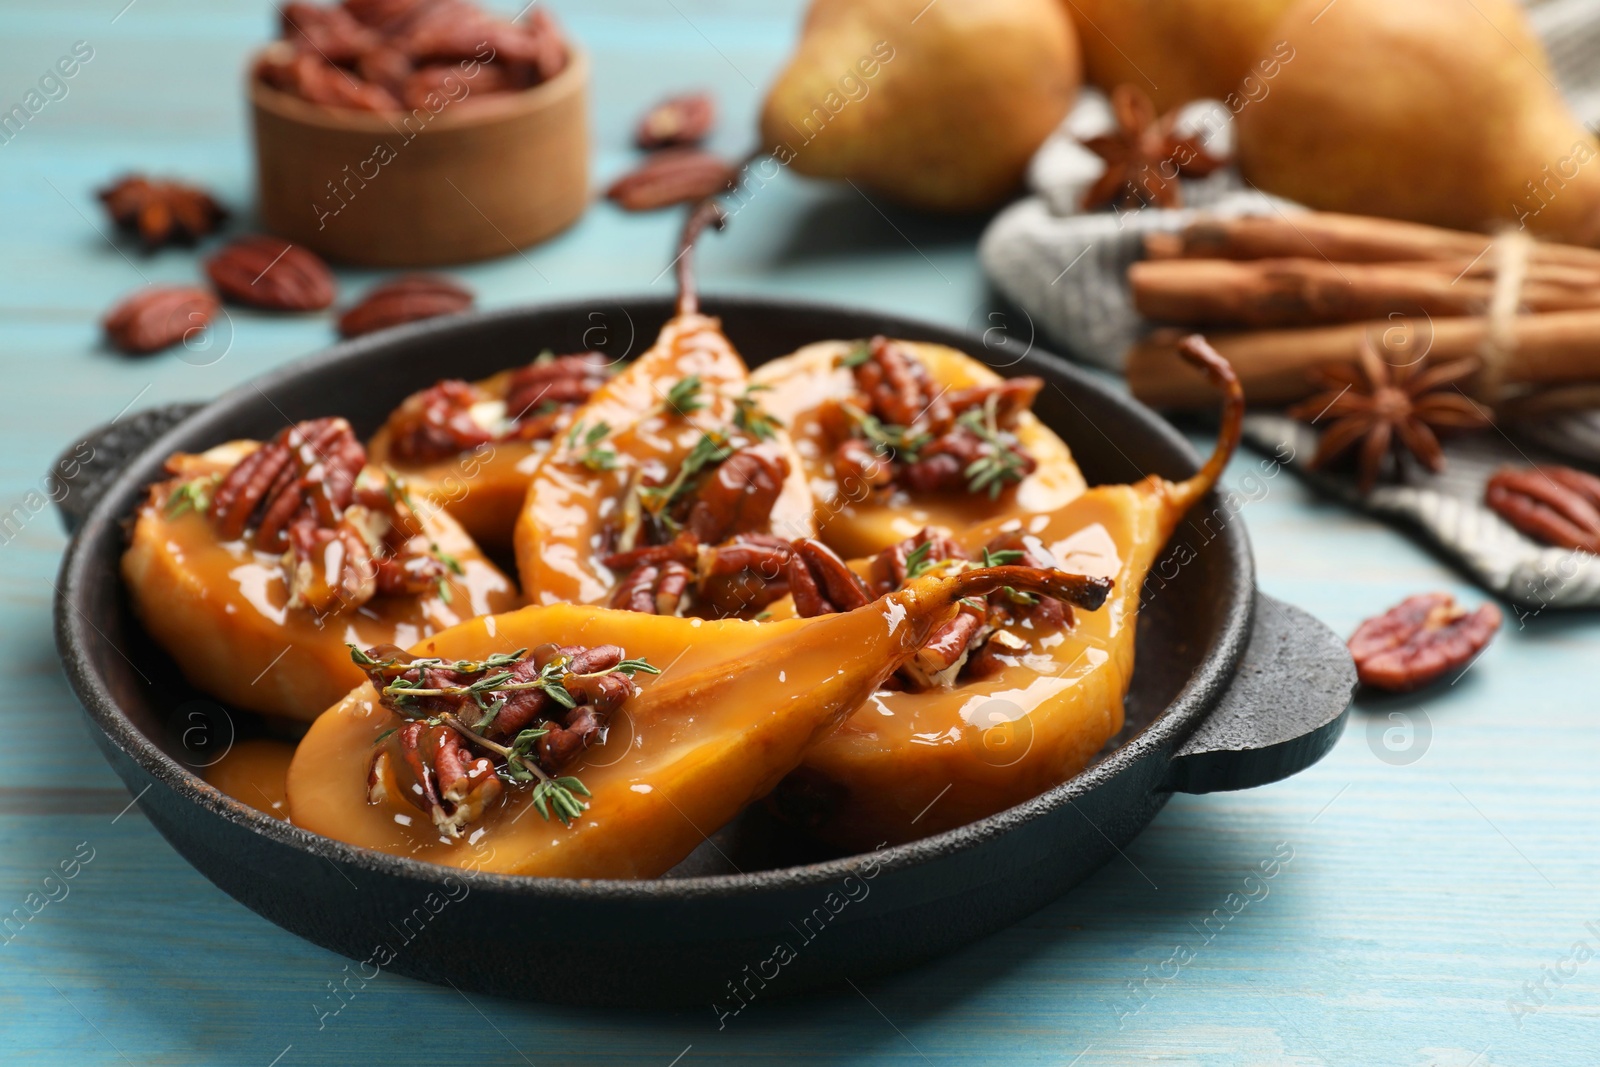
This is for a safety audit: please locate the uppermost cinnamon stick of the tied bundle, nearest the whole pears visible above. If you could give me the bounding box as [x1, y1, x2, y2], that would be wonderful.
[1144, 211, 1600, 270]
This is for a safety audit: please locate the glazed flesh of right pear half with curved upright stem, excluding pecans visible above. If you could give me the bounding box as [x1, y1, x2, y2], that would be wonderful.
[773, 480, 1170, 848]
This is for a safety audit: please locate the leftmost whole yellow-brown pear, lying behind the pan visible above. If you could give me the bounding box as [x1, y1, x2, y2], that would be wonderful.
[762, 0, 1078, 211]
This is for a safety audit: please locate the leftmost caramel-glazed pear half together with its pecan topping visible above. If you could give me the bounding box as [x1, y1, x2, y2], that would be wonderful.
[122, 418, 518, 718]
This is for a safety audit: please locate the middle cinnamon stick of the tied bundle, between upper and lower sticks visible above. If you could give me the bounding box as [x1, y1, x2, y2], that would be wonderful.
[1128, 259, 1600, 326]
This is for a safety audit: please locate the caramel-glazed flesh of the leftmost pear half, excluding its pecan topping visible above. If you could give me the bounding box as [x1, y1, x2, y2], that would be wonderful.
[122, 443, 518, 720]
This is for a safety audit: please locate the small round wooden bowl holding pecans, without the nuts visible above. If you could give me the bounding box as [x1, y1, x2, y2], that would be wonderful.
[250, 48, 589, 267]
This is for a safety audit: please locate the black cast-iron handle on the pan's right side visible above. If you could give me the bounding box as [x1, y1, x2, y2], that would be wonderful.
[1163, 593, 1355, 793]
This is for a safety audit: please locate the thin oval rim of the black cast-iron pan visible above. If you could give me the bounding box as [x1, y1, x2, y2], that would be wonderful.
[54, 294, 1254, 901]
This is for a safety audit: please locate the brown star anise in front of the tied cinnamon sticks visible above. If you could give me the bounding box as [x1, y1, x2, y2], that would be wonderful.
[1290, 338, 1493, 493]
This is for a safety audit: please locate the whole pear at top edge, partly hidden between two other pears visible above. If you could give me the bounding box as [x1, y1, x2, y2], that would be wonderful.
[1059, 0, 1299, 112]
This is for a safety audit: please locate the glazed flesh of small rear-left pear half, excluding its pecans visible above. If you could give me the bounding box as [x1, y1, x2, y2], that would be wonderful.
[366, 371, 566, 549]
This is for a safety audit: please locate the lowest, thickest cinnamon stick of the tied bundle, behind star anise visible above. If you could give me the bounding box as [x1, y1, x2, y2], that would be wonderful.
[1123, 310, 1600, 408]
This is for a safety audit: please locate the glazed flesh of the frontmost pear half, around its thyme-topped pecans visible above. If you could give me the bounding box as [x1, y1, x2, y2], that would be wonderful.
[288, 579, 985, 878]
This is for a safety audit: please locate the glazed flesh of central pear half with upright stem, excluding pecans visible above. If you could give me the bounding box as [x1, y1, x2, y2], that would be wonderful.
[515, 315, 813, 605]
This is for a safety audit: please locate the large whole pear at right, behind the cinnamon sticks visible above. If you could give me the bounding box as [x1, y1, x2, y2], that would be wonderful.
[1237, 0, 1600, 245]
